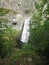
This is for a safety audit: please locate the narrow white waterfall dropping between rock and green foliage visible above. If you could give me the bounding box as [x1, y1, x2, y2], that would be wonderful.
[21, 17, 30, 43]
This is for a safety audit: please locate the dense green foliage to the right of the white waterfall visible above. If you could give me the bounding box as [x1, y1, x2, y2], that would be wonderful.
[23, 0, 49, 65]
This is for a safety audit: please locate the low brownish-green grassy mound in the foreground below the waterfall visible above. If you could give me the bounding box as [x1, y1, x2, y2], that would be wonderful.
[2, 49, 36, 65]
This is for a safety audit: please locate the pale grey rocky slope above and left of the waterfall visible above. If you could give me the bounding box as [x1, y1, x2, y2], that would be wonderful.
[0, 0, 38, 29]
